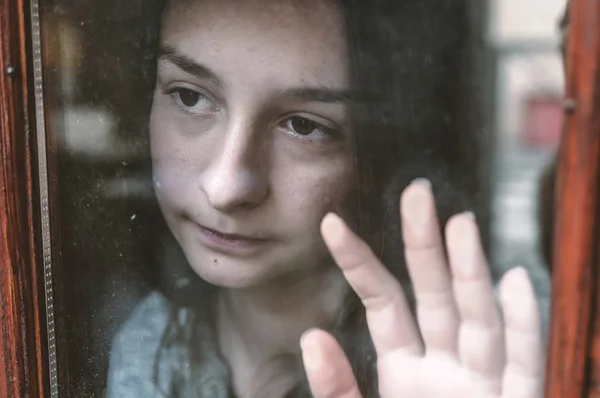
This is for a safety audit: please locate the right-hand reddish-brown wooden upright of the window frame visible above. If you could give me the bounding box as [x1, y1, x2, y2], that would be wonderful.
[546, 0, 600, 398]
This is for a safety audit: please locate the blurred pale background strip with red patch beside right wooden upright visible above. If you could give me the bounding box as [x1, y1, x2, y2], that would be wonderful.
[487, 0, 566, 318]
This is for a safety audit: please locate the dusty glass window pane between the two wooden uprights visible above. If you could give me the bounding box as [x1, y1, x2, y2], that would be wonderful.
[40, 0, 565, 398]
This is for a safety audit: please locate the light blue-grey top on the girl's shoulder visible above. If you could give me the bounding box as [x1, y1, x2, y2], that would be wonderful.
[106, 292, 548, 398]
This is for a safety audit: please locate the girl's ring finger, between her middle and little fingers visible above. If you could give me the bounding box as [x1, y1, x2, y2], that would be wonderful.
[446, 213, 504, 382]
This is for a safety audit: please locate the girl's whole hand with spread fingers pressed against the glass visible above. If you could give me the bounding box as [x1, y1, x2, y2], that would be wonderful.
[301, 181, 544, 398]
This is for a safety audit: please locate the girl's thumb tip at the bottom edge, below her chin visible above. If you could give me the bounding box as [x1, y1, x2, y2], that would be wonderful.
[300, 330, 361, 398]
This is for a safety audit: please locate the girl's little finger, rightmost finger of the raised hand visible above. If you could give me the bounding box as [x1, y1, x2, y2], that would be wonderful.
[500, 267, 545, 398]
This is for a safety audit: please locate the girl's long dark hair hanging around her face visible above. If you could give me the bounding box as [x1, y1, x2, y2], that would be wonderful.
[138, 0, 484, 397]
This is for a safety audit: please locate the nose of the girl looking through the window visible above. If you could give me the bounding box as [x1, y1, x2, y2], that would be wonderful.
[200, 121, 269, 212]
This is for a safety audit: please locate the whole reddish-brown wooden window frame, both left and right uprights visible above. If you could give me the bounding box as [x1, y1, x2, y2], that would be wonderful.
[0, 0, 600, 398]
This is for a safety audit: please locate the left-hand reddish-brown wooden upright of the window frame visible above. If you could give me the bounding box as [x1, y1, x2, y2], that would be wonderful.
[0, 0, 47, 397]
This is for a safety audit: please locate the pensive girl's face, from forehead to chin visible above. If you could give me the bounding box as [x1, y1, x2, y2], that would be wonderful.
[150, 0, 352, 288]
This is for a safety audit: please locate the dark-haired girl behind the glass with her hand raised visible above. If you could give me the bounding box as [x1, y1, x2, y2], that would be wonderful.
[108, 0, 543, 398]
